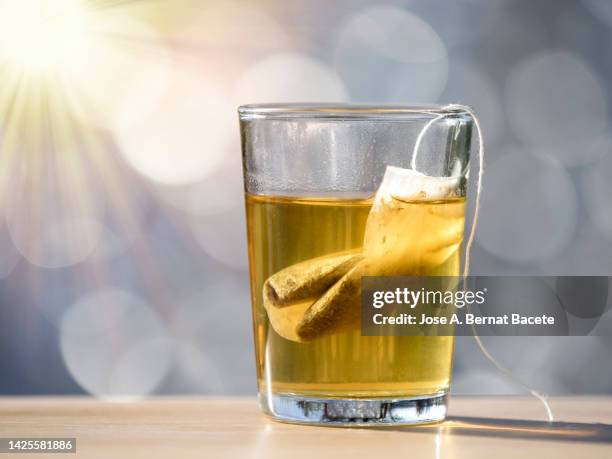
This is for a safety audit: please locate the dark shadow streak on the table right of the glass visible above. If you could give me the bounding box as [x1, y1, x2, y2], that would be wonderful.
[402, 416, 612, 443]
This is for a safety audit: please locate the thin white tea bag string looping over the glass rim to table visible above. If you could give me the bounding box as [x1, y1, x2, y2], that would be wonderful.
[410, 104, 554, 422]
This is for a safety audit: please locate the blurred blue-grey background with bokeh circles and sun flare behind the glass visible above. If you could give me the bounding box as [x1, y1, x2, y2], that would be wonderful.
[0, 0, 612, 396]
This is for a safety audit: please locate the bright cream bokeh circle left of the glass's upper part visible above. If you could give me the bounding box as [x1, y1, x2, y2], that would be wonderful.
[115, 70, 232, 186]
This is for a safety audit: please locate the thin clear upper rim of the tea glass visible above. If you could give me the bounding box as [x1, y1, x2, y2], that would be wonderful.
[238, 102, 471, 120]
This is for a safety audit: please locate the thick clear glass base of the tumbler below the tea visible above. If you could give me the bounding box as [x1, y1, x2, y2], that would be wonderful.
[259, 392, 448, 427]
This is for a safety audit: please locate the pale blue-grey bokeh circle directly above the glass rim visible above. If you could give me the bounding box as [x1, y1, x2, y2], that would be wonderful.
[334, 6, 448, 103]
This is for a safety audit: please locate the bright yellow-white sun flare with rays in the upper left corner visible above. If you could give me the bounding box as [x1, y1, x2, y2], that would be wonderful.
[0, 0, 172, 268]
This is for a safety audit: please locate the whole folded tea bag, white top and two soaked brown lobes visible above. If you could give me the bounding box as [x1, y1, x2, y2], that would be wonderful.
[263, 167, 465, 341]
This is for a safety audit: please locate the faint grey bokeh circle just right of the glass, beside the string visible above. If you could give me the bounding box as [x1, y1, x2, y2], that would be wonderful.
[477, 151, 578, 263]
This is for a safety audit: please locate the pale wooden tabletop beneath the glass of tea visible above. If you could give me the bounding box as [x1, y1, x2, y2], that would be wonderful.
[0, 397, 612, 459]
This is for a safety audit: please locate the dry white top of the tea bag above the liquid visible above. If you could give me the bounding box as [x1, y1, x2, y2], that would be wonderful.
[374, 166, 461, 210]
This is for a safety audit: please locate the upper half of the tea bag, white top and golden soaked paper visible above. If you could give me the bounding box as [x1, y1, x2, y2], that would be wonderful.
[363, 166, 465, 276]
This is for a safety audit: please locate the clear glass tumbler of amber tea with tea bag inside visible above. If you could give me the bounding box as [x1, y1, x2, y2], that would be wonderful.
[238, 104, 473, 425]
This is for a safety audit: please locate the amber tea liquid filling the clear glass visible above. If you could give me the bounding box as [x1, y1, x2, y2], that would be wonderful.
[246, 195, 465, 398]
